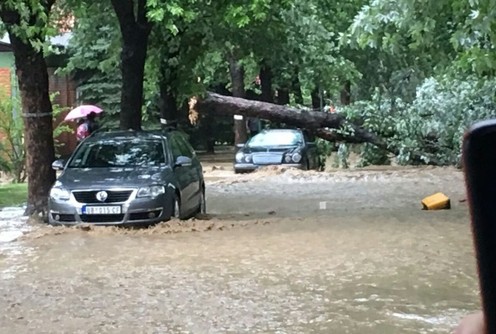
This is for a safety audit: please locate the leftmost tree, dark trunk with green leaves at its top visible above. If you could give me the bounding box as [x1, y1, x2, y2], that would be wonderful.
[0, 0, 55, 215]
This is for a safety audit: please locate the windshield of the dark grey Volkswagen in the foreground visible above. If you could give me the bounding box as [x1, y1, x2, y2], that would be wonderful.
[68, 139, 167, 168]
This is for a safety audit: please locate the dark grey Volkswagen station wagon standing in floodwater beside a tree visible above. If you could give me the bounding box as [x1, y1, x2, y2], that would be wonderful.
[48, 130, 206, 225]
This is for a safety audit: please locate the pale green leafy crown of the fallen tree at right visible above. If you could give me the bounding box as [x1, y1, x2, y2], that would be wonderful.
[344, 75, 496, 165]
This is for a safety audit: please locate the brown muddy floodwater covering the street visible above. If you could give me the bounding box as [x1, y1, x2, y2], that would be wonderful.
[0, 168, 480, 334]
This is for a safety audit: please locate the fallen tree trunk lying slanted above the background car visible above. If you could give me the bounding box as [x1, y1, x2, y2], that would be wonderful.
[189, 93, 438, 164]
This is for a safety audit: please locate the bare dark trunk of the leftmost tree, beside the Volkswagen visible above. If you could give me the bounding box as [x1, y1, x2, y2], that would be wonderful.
[6, 33, 55, 215]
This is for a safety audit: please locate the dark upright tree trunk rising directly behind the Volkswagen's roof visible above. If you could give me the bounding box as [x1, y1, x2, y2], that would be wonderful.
[112, 0, 151, 130]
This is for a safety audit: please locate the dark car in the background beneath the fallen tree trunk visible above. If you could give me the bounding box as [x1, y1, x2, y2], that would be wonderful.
[234, 129, 319, 173]
